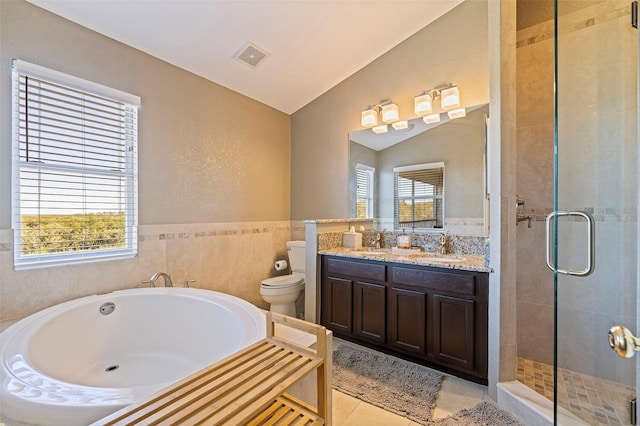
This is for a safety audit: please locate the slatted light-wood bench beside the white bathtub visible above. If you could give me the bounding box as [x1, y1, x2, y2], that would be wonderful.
[99, 312, 331, 426]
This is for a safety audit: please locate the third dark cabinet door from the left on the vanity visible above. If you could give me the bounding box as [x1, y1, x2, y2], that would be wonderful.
[389, 287, 427, 354]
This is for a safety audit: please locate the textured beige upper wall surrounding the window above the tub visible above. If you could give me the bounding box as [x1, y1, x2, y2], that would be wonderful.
[0, 1, 290, 228]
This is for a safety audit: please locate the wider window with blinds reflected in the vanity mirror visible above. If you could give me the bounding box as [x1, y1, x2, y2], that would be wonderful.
[393, 163, 444, 230]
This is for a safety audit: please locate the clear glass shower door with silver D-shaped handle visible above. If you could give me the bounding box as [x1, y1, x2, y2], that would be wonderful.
[547, 0, 640, 425]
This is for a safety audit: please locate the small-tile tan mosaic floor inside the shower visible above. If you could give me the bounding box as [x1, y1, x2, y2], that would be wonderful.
[517, 358, 635, 425]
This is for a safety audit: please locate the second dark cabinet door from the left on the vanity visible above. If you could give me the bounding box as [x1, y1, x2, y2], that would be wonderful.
[354, 281, 387, 343]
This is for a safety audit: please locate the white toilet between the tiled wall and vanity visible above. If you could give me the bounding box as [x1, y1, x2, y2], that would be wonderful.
[260, 241, 305, 317]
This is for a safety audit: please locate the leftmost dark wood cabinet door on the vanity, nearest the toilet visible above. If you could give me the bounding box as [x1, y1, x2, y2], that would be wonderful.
[322, 277, 353, 334]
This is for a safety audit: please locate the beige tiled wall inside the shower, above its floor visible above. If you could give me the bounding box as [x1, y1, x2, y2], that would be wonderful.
[517, 2, 638, 384]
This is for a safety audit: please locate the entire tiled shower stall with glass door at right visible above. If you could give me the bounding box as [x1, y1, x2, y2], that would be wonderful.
[514, 0, 640, 425]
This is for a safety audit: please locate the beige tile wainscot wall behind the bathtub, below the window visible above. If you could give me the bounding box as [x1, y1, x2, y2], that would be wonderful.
[0, 221, 291, 321]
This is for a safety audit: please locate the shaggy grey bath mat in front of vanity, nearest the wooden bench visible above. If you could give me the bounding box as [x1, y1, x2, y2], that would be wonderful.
[332, 344, 444, 424]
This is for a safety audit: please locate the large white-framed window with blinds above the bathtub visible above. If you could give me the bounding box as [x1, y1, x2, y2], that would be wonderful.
[12, 60, 140, 269]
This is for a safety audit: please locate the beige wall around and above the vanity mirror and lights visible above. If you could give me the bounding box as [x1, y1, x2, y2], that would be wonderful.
[291, 0, 489, 219]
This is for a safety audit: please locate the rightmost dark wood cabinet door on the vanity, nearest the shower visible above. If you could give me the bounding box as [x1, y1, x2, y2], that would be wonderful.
[433, 294, 475, 370]
